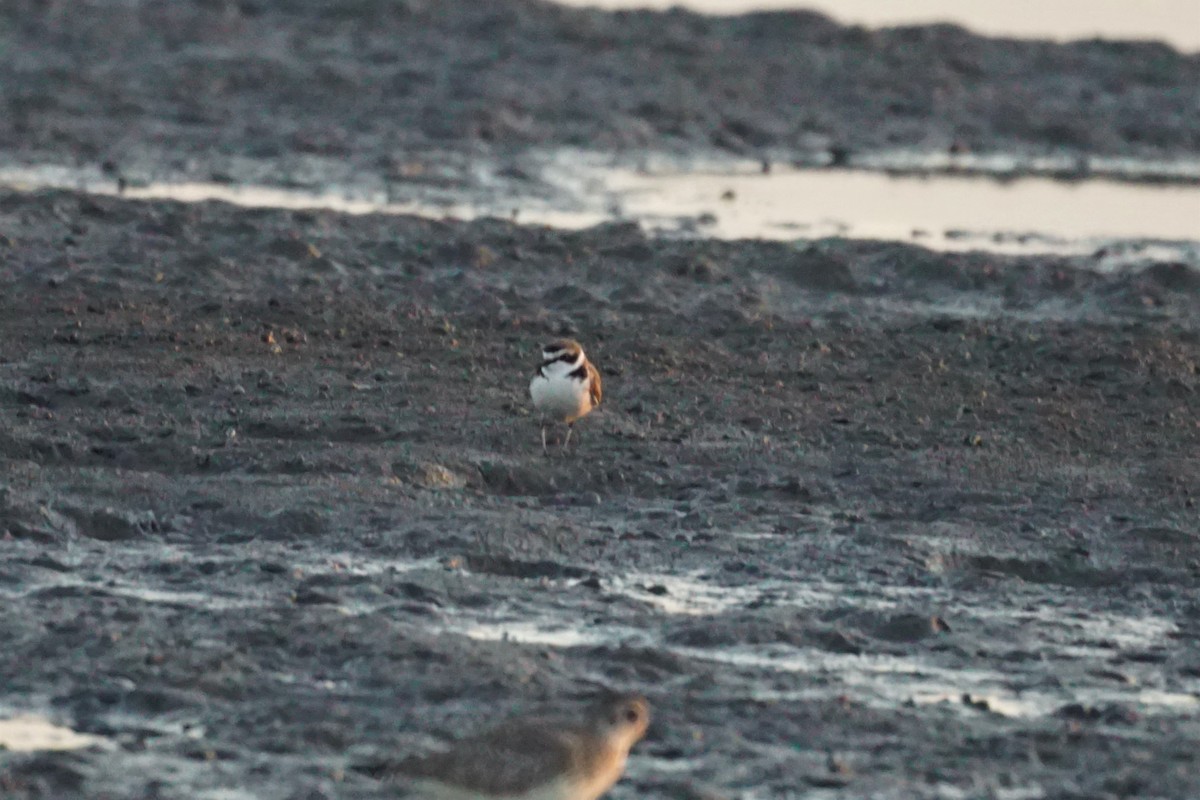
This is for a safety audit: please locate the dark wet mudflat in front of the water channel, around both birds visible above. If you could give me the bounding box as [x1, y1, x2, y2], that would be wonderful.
[0, 193, 1200, 800]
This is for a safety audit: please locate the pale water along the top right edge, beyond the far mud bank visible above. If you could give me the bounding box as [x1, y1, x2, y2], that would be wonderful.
[558, 0, 1200, 50]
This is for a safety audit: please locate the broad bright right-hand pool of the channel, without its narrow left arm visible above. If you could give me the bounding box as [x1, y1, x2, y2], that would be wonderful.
[607, 170, 1200, 253]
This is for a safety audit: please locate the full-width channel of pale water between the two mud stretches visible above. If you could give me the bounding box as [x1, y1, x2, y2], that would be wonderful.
[0, 150, 1200, 260]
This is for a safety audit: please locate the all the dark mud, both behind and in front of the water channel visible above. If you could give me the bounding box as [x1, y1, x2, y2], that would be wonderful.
[0, 0, 1200, 800]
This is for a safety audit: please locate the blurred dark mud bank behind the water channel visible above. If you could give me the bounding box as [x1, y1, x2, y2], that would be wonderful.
[0, 0, 1200, 185]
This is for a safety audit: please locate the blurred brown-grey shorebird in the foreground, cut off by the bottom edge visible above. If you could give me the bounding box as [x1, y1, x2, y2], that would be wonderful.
[396, 694, 650, 800]
